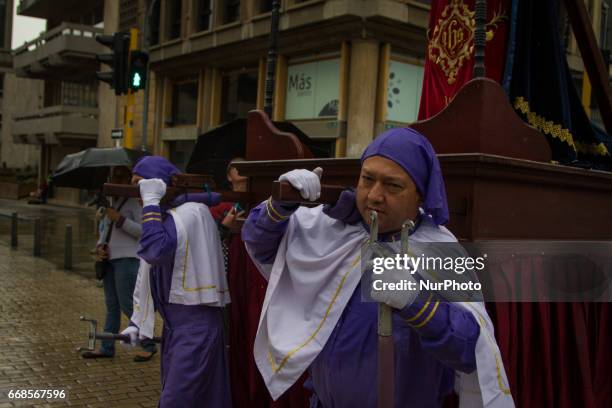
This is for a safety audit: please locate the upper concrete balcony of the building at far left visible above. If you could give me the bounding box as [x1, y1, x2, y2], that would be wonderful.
[13, 23, 104, 81]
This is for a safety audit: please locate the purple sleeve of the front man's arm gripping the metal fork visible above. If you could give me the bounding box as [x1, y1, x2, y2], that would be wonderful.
[400, 293, 480, 373]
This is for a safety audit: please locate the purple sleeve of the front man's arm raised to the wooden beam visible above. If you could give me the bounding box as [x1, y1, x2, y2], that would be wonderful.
[242, 199, 298, 264]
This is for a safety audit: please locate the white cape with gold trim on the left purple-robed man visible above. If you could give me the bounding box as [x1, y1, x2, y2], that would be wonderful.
[131, 203, 230, 338]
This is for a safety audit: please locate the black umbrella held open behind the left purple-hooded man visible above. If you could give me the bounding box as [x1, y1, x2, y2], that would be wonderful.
[51, 147, 149, 190]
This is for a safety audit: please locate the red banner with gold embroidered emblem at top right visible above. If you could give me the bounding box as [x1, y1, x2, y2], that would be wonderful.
[419, 0, 511, 120]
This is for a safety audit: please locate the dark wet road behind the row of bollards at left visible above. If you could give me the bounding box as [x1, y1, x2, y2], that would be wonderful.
[0, 199, 97, 278]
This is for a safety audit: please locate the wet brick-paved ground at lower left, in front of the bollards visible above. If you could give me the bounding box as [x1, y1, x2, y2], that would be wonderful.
[0, 241, 161, 408]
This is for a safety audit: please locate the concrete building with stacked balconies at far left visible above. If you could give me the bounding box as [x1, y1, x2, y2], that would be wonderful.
[5, 0, 106, 202]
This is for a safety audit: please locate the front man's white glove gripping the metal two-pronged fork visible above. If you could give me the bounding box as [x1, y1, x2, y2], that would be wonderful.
[370, 262, 419, 309]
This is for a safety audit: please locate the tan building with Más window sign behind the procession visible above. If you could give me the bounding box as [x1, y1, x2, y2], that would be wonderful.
[100, 0, 429, 166]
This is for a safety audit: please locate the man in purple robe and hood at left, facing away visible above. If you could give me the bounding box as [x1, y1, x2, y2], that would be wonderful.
[124, 156, 231, 407]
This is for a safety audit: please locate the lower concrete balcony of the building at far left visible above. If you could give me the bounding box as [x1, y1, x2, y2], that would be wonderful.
[11, 105, 98, 147]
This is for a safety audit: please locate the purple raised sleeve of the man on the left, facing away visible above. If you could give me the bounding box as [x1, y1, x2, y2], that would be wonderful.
[138, 205, 176, 265]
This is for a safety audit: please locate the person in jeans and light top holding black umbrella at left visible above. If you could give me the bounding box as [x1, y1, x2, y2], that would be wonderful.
[53, 148, 157, 361]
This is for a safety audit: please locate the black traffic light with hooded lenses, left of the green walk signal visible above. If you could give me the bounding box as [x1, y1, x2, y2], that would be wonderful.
[96, 32, 130, 95]
